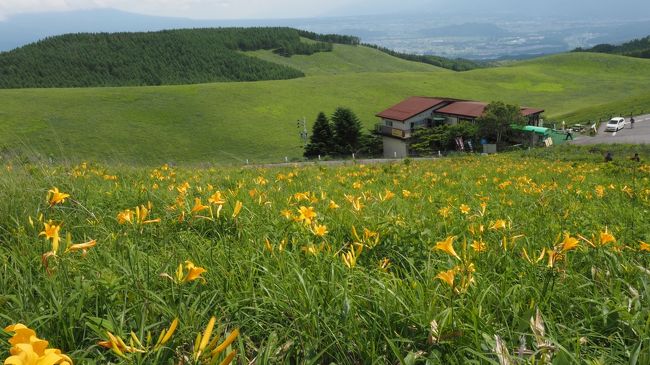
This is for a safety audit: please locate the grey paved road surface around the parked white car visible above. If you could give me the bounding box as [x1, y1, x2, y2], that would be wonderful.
[569, 114, 650, 145]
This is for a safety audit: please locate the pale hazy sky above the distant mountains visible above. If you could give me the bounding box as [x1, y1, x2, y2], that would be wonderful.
[0, 0, 650, 19]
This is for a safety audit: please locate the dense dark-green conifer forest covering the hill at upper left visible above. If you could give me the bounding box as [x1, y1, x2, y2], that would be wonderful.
[0, 28, 332, 88]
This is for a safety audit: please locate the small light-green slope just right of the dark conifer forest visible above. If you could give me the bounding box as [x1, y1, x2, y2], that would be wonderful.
[246, 44, 442, 76]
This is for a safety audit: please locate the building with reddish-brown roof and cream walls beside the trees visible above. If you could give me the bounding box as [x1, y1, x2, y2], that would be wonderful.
[376, 96, 544, 158]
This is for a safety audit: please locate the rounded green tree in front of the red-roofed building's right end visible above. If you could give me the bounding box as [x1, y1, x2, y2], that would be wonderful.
[476, 101, 526, 144]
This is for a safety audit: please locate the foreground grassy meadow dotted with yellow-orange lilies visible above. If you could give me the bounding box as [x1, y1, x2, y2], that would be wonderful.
[0, 147, 650, 364]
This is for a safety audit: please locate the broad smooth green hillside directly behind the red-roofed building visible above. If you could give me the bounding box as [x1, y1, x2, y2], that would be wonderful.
[0, 53, 650, 164]
